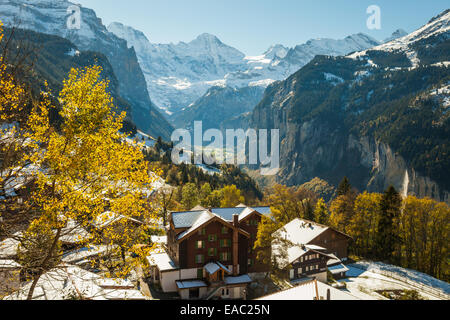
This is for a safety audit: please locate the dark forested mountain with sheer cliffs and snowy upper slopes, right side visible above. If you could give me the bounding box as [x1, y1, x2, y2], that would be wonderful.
[246, 10, 450, 202]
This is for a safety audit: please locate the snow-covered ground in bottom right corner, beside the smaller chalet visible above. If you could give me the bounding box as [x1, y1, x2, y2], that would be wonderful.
[340, 262, 448, 300]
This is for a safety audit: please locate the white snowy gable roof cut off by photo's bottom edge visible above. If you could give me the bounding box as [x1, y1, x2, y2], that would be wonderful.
[257, 280, 359, 301]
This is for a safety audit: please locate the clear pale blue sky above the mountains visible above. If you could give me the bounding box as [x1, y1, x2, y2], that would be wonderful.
[73, 0, 450, 55]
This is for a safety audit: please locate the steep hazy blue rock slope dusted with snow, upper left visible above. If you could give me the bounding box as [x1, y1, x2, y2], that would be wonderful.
[0, 0, 171, 137]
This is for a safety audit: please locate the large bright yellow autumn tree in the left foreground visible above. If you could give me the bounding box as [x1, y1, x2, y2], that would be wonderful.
[12, 66, 156, 299]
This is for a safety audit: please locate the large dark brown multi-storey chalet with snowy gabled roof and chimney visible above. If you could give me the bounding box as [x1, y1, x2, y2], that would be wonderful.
[148, 205, 270, 299]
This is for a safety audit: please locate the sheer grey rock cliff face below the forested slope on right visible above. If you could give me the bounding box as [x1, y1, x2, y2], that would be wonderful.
[252, 102, 450, 203]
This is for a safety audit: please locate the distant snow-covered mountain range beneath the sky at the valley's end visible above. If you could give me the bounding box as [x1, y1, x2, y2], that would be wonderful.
[108, 23, 380, 115]
